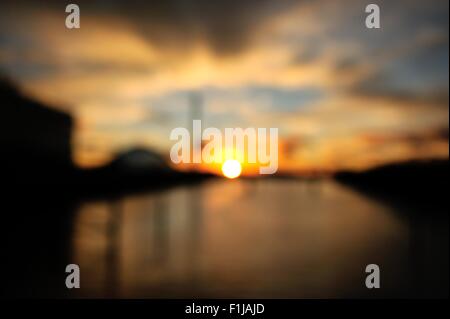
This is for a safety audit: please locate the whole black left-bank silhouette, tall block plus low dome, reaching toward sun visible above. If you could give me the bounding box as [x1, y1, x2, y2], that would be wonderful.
[0, 79, 212, 193]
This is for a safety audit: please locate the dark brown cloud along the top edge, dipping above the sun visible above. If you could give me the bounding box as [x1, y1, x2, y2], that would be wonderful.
[2, 0, 299, 55]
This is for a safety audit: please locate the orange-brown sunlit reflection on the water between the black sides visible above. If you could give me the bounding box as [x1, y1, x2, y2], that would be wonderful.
[72, 179, 448, 298]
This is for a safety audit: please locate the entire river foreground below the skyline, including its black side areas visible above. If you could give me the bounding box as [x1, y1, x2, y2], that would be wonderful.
[2, 171, 448, 298]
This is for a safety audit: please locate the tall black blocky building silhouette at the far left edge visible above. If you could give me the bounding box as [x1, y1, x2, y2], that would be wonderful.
[0, 80, 73, 183]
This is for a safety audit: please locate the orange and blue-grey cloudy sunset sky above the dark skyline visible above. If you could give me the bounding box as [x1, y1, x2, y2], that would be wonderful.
[0, 0, 449, 172]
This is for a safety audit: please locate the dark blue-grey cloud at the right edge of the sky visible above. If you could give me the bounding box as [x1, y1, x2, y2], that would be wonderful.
[344, 30, 449, 106]
